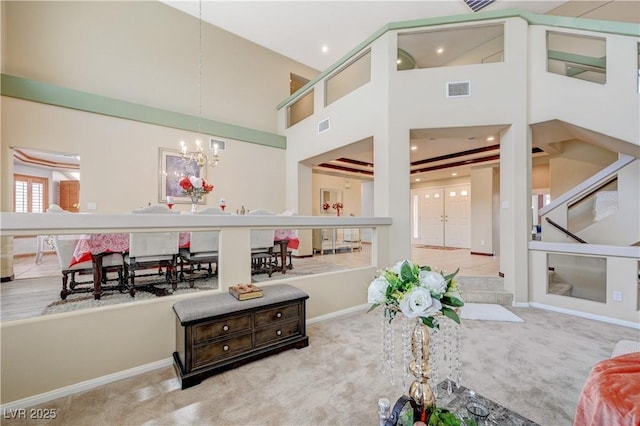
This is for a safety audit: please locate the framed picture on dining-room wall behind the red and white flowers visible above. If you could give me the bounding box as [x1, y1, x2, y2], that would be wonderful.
[158, 148, 207, 204]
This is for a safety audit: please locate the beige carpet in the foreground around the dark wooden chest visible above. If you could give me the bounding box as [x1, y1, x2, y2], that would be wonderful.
[20, 308, 638, 426]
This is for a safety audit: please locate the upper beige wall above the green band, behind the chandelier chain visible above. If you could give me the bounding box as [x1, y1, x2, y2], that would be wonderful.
[2, 1, 317, 133]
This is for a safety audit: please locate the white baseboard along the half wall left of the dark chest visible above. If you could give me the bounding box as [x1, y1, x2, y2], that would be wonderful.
[0, 358, 173, 413]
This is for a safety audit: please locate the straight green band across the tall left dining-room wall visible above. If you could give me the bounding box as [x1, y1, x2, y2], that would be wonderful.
[0, 74, 287, 149]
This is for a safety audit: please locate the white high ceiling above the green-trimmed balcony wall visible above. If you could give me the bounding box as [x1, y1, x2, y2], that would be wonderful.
[162, 0, 568, 71]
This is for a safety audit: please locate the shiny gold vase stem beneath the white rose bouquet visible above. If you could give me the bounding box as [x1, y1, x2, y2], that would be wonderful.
[409, 318, 436, 423]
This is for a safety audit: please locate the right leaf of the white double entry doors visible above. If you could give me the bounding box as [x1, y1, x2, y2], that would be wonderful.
[444, 185, 471, 248]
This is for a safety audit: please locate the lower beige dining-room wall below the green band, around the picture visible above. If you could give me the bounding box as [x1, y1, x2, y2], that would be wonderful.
[2, 97, 285, 213]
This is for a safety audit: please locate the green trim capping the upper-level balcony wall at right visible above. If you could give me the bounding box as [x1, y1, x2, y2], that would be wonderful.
[278, 9, 640, 109]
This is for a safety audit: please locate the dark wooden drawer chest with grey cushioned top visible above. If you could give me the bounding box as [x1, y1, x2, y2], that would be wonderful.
[173, 284, 309, 389]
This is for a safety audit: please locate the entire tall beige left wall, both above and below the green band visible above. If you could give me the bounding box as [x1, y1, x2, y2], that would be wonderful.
[0, 2, 317, 213]
